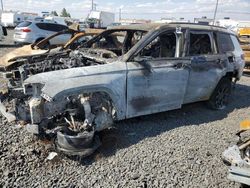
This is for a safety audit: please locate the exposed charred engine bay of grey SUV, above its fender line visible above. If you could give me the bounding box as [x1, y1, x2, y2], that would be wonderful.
[0, 49, 117, 93]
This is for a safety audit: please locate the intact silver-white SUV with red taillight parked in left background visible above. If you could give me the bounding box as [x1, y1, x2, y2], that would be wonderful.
[14, 21, 71, 45]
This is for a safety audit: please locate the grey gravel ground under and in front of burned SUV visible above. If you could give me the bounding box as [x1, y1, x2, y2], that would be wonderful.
[0, 28, 250, 188]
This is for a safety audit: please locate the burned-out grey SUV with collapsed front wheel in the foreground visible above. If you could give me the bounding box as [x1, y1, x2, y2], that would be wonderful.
[6, 23, 245, 156]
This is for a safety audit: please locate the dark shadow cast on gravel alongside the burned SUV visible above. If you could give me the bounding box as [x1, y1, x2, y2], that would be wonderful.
[94, 84, 250, 158]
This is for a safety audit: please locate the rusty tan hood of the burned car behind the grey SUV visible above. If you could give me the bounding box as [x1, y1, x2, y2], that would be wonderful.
[0, 45, 49, 68]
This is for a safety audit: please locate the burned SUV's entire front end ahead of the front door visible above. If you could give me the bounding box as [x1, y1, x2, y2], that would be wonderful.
[2, 26, 146, 156]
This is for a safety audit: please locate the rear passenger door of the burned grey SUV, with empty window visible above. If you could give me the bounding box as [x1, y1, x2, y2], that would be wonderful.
[184, 30, 228, 103]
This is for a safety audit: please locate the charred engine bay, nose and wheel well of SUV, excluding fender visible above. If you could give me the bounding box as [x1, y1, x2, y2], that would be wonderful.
[0, 49, 117, 156]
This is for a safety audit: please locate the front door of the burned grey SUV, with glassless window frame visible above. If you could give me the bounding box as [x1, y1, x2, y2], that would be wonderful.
[127, 31, 190, 118]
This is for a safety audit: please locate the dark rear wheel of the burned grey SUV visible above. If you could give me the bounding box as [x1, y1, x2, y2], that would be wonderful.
[208, 77, 232, 110]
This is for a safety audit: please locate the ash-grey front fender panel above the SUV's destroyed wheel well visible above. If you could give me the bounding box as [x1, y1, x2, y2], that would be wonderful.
[24, 62, 126, 101]
